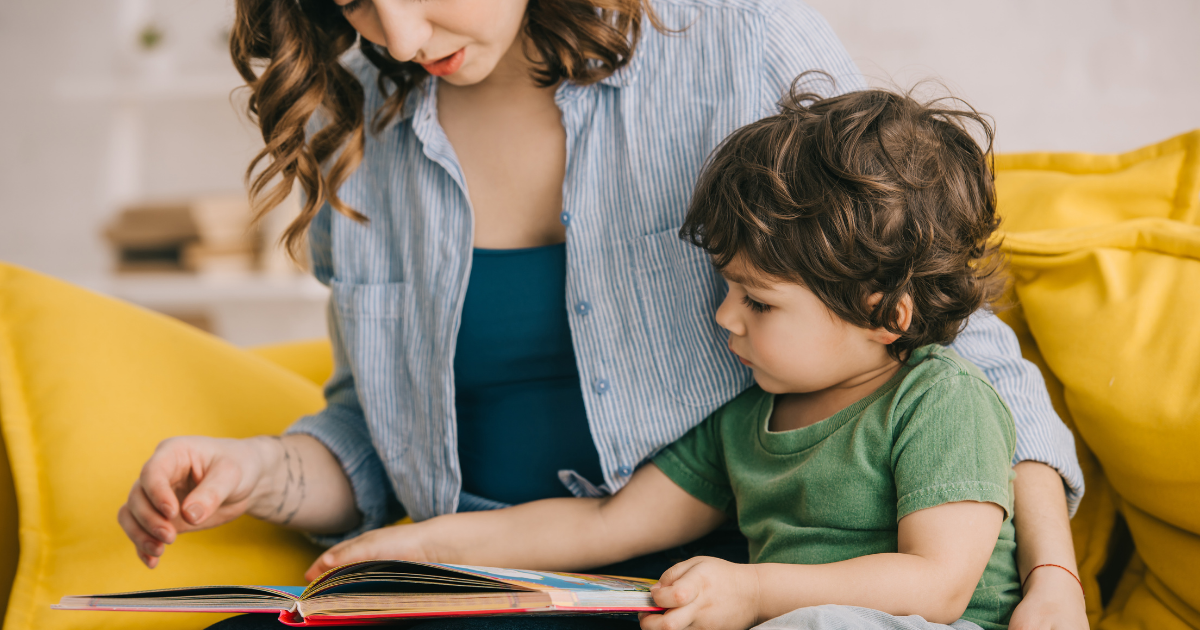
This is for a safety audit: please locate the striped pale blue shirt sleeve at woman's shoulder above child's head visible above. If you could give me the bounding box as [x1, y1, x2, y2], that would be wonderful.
[762, 0, 866, 114]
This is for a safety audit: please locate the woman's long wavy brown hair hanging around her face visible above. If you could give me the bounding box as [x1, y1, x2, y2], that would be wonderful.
[229, 0, 666, 256]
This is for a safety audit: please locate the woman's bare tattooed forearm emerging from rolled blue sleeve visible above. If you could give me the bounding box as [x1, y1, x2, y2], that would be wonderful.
[247, 434, 362, 534]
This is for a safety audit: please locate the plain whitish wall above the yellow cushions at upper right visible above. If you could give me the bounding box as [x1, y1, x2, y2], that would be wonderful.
[809, 0, 1200, 152]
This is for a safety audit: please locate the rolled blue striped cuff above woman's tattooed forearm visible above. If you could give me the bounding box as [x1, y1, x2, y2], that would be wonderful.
[286, 406, 403, 547]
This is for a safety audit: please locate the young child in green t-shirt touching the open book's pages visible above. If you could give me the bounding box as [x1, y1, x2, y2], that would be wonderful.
[309, 90, 1020, 630]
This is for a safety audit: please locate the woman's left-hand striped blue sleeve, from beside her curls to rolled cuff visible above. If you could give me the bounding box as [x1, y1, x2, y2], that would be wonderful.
[286, 204, 403, 546]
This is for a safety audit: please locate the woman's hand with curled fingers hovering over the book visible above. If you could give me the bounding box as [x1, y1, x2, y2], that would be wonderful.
[116, 437, 280, 569]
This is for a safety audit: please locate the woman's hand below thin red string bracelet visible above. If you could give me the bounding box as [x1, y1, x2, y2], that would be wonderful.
[1008, 566, 1087, 630]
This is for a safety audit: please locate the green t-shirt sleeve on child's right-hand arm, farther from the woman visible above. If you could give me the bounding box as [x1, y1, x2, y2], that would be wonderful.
[892, 374, 1016, 521]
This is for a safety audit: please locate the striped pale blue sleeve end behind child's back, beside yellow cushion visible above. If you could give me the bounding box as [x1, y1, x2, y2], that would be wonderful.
[950, 310, 1084, 516]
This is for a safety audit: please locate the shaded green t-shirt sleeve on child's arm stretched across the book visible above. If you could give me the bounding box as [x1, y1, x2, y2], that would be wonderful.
[654, 410, 733, 514]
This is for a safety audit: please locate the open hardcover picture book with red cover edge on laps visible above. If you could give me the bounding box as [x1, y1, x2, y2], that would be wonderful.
[54, 560, 662, 626]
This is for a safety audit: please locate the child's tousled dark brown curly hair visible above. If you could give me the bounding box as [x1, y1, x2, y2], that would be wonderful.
[680, 77, 1003, 360]
